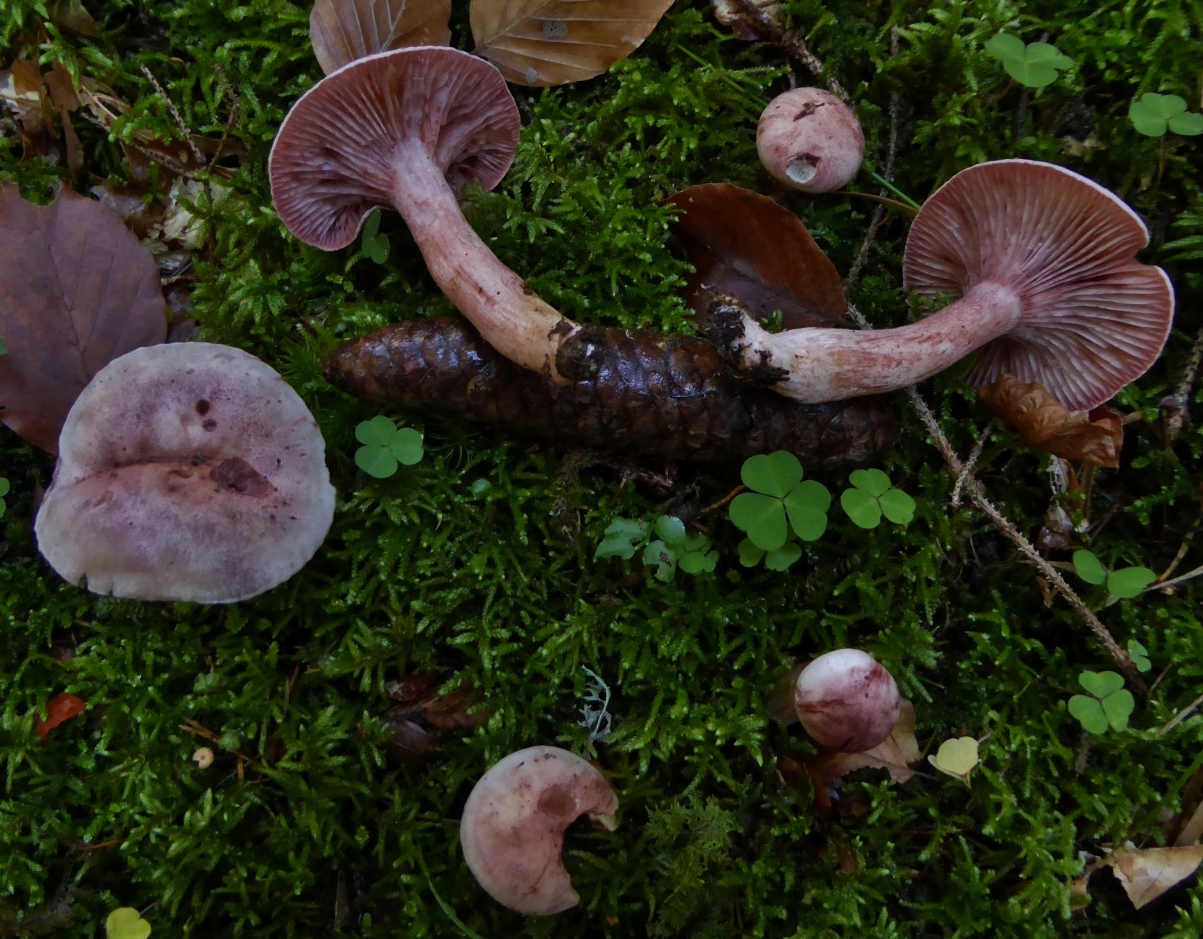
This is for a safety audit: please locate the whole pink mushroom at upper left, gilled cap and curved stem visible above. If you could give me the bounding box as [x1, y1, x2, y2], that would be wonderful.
[268, 47, 576, 384]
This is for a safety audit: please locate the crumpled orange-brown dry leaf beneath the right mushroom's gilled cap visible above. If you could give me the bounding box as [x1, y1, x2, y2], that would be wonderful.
[977, 375, 1124, 469]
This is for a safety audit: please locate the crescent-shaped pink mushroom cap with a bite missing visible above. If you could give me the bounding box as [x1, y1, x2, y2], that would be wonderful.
[460, 747, 618, 916]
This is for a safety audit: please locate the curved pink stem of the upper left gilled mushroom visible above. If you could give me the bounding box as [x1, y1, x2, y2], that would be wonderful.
[392, 139, 580, 385]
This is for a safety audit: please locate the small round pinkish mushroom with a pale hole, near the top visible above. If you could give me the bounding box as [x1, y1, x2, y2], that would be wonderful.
[755, 88, 865, 192]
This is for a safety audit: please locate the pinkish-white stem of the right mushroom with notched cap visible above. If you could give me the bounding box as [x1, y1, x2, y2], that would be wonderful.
[710, 281, 1020, 404]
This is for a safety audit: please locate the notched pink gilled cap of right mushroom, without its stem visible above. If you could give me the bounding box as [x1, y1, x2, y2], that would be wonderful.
[902, 160, 1174, 410]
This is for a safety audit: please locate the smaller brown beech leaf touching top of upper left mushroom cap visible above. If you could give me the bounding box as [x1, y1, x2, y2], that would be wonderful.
[309, 0, 451, 75]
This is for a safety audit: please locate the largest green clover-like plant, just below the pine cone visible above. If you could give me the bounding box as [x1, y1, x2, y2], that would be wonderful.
[728, 450, 831, 570]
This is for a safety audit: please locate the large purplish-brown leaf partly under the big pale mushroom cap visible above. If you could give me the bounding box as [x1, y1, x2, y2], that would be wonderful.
[0, 185, 167, 453]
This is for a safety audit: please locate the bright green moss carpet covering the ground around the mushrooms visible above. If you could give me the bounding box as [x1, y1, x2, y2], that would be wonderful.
[0, 0, 1203, 939]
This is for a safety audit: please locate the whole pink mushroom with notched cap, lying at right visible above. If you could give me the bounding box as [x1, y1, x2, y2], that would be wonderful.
[707, 160, 1174, 410]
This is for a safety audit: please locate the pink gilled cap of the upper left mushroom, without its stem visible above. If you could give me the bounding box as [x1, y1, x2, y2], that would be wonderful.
[268, 47, 521, 251]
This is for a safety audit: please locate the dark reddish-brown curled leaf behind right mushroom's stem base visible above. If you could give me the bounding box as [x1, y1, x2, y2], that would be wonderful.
[665, 183, 848, 329]
